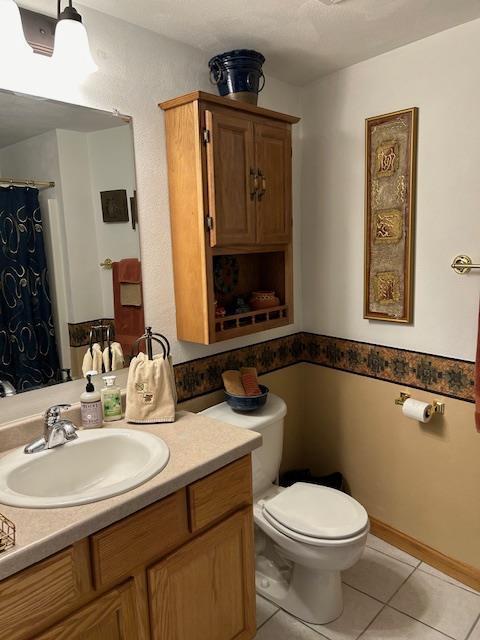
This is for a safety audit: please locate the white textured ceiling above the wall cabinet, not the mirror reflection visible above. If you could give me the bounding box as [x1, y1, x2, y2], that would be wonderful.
[51, 0, 480, 85]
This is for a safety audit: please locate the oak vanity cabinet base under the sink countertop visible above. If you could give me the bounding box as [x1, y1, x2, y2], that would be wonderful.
[0, 456, 256, 640]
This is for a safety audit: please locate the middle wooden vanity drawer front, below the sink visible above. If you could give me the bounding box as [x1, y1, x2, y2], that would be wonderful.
[90, 489, 190, 589]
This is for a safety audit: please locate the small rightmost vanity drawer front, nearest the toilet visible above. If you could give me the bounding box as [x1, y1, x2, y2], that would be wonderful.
[187, 456, 252, 532]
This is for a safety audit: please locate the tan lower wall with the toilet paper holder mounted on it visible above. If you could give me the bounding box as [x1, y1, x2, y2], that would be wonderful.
[299, 364, 480, 568]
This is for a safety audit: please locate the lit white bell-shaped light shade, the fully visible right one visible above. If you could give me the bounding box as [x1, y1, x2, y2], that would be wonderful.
[52, 14, 98, 76]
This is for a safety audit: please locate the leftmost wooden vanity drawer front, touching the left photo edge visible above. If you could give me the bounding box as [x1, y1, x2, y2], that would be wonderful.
[0, 540, 91, 640]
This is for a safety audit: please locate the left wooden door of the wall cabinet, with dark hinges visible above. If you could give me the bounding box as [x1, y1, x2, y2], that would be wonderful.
[205, 111, 256, 247]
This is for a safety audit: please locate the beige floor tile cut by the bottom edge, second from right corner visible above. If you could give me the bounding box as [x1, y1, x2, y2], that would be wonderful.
[361, 607, 447, 640]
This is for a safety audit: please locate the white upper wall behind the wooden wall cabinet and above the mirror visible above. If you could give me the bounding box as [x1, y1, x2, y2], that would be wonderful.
[0, 3, 302, 362]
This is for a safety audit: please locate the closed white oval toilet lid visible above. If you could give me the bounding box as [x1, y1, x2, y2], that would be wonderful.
[263, 482, 368, 540]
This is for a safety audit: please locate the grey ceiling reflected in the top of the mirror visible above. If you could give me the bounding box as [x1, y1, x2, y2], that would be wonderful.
[0, 91, 125, 149]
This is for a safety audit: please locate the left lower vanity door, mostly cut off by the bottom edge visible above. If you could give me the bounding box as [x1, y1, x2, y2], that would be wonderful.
[35, 582, 140, 640]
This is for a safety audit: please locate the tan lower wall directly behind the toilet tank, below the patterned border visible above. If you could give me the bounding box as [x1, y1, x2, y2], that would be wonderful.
[179, 365, 304, 471]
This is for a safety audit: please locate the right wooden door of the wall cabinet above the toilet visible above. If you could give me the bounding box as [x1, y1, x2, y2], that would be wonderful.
[255, 124, 292, 244]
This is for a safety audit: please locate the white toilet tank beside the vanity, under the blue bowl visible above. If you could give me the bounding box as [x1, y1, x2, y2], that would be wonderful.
[201, 393, 287, 495]
